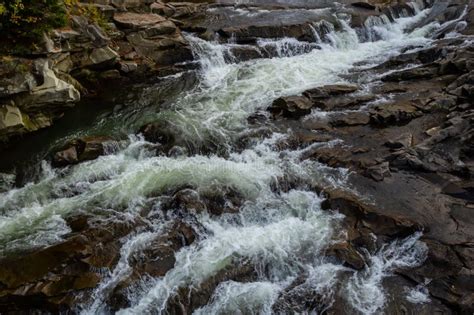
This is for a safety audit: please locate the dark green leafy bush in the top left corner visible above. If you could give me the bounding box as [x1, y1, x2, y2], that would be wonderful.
[0, 0, 67, 53]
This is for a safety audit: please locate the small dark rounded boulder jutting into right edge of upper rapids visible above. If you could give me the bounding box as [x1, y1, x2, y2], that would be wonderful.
[268, 96, 313, 118]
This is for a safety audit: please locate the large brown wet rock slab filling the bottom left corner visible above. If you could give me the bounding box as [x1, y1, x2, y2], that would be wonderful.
[0, 217, 141, 313]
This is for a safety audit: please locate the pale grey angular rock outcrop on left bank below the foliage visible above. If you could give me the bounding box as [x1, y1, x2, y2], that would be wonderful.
[0, 58, 81, 141]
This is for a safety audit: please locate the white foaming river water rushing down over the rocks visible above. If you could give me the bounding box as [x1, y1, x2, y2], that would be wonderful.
[0, 1, 462, 314]
